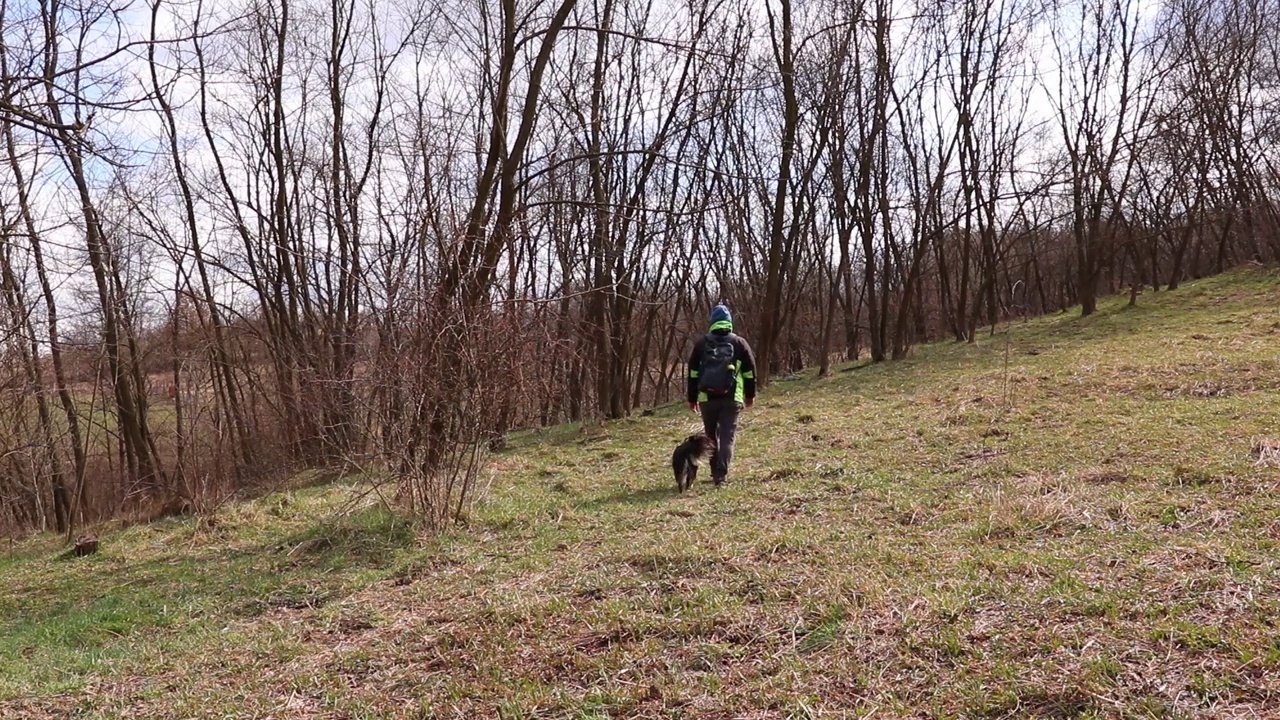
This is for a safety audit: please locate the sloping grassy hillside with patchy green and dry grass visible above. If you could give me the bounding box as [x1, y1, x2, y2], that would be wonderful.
[0, 270, 1280, 719]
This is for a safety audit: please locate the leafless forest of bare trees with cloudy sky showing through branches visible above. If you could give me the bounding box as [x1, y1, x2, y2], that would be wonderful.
[0, 0, 1280, 534]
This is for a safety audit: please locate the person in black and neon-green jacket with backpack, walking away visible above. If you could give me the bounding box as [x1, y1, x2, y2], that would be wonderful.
[687, 302, 755, 487]
